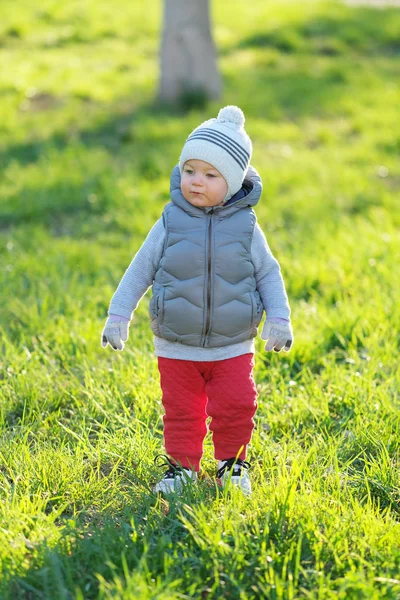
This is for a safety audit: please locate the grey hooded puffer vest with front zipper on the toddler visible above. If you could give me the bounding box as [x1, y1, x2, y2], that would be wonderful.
[150, 166, 263, 348]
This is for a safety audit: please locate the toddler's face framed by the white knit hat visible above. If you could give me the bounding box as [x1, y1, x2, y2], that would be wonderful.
[181, 159, 228, 207]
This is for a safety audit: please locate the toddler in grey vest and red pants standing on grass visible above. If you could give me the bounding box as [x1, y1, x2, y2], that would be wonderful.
[102, 106, 293, 494]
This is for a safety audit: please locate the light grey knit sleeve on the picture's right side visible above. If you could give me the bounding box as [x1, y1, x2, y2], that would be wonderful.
[251, 223, 290, 320]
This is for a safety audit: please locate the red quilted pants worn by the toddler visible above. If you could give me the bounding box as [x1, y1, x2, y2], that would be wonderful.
[158, 354, 257, 471]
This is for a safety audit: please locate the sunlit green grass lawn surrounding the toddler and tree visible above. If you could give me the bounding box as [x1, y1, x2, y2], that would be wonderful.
[0, 0, 400, 600]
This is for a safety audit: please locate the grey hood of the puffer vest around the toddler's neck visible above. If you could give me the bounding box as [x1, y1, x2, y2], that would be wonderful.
[170, 165, 262, 217]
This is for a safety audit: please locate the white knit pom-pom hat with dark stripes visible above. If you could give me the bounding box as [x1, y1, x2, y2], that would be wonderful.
[179, 106, 253, 201]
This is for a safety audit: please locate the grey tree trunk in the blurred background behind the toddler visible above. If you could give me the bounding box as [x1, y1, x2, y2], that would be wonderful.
[158, 0, 221, 102]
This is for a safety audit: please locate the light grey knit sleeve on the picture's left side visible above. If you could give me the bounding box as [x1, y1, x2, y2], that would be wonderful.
[108, 218, 165, 319]
